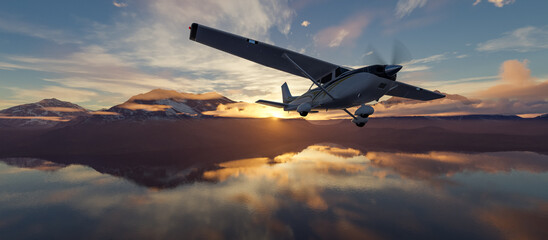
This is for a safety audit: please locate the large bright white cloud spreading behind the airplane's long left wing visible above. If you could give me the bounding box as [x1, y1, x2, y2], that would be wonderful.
[103, 0, 300, 101]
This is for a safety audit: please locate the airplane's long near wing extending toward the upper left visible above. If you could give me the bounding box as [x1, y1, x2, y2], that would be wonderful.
[190, 23, 349, 83]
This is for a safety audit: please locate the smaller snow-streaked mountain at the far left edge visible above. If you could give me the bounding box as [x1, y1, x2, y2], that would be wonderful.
[0, 98, 88, 128]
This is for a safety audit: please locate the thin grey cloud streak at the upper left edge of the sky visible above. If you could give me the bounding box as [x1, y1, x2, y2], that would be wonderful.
[0, 18, 82, 44]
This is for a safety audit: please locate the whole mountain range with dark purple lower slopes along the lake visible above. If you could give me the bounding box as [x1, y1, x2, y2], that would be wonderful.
[0, 89, 548, 165]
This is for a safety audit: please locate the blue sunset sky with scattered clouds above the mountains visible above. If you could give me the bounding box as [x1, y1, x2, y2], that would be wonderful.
[0, 0, 548, 115]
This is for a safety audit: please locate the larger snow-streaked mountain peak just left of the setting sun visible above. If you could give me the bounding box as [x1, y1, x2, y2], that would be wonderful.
[107, 89, 234, 118]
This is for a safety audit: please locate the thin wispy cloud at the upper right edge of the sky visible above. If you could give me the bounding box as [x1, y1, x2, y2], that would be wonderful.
[476, 26, 548, 52]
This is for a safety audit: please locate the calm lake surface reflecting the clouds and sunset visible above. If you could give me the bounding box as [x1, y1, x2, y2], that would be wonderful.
[0, 144, 548, 239]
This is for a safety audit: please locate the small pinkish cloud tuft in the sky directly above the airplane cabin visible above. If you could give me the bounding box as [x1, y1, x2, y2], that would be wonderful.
[314, 13, 370, 48]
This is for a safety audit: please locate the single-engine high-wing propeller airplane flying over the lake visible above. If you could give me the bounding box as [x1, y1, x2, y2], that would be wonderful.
[190, 23, 445, 127]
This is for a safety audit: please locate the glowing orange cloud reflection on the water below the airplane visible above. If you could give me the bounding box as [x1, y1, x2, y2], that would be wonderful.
[203, 144, 367, 214]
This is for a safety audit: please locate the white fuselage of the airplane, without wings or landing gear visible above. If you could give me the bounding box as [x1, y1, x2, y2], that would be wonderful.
[285, 72, 394, 110]
